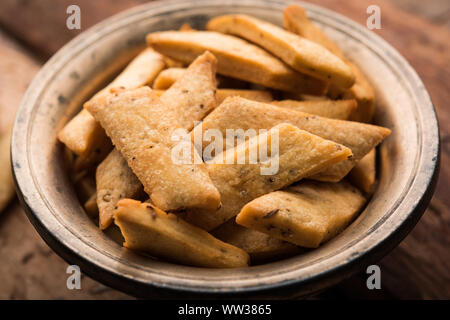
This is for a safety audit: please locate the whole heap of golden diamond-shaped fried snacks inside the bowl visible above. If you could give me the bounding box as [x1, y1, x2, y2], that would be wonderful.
[59, 5, 391, 268]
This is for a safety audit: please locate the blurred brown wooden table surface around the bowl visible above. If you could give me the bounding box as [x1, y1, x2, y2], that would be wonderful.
[0, 0, 450, 299]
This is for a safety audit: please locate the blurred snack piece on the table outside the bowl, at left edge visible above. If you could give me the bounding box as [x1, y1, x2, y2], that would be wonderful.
[0, 130, 16, 212]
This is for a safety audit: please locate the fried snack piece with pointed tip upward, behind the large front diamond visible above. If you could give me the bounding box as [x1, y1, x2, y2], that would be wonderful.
[161, 51, 217, 131]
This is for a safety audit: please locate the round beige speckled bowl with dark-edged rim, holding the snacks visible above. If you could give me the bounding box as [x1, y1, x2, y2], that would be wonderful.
[11, 0, 439, 298]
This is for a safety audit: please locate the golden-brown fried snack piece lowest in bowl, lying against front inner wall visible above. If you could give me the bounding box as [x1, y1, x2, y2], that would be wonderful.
[114, 199, 249, 268]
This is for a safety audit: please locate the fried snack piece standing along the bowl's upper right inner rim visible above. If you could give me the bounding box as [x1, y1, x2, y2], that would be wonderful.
[283, 4, 375, 122]
